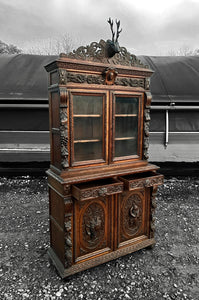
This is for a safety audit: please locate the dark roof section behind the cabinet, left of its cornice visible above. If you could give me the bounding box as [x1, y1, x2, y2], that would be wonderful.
[0, 54, 57, 100]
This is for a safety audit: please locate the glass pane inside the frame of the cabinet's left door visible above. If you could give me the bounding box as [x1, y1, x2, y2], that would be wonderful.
[73, 95, 103, 162]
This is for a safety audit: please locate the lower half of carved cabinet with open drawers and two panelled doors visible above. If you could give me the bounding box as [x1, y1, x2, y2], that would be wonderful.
[48, 172, 163, 277]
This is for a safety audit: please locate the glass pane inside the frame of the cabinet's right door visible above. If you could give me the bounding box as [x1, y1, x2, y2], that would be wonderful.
[115, 97, 139, 157]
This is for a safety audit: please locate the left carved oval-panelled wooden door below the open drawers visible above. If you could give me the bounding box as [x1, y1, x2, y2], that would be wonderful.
[74, 196, 114, 262]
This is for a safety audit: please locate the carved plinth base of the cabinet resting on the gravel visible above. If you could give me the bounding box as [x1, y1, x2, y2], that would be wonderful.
[48, 239, 155, 278]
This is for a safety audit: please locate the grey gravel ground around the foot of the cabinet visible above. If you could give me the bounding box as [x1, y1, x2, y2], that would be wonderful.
[0, 176, 199, 300]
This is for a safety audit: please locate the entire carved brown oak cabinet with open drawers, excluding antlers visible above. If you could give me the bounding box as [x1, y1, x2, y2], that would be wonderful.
[45, 40, 163, 277]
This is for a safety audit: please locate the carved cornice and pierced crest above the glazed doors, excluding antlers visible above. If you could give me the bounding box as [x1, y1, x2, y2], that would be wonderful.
[45, 40, 153, 90]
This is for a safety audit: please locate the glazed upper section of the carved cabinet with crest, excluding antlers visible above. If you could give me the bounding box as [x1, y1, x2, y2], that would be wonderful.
[45, 40, 153, 175]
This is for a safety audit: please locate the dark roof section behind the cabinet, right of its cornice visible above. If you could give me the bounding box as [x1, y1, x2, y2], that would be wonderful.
[139, 56, 199, 102]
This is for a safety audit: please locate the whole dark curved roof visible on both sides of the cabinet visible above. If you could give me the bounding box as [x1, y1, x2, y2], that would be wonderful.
[0, 54, 199, 102]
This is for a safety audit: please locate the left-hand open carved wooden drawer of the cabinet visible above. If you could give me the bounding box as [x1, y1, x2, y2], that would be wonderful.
[72, 178, 124, 200]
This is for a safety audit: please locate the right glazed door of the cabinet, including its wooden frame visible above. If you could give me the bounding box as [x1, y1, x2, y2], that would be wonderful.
[110, 93, 143, 161]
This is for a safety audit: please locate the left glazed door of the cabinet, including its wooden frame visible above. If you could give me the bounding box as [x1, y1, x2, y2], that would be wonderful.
[69, 91, 108, 166]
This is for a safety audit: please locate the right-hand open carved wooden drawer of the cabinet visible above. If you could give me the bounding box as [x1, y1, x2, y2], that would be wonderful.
[119, 172, 164, 191]
